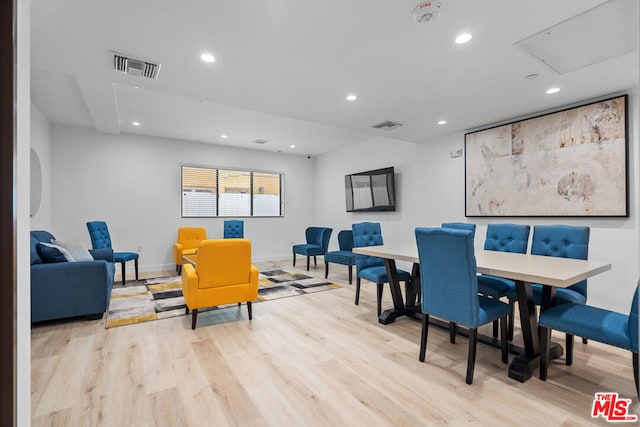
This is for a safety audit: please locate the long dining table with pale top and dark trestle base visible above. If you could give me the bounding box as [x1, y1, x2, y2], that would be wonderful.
[353, 243, 611, 382]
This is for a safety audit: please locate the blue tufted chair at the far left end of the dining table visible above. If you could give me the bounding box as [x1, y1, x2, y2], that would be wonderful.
[351, 222, 411, 317]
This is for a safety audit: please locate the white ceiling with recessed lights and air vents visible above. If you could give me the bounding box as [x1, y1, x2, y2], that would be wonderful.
[31, 0, 639, 155]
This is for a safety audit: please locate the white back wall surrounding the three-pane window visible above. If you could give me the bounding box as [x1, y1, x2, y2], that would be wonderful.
[50, 125, 314, 272]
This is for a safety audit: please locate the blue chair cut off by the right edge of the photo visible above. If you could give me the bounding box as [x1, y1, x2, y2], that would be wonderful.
[539, 282, 640, 397]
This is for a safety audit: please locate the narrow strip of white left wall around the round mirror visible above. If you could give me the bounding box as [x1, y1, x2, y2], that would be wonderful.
[31, 104, 51, 230]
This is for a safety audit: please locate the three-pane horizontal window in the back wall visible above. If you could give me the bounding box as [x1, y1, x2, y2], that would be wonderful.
[182, 166, 283, 217]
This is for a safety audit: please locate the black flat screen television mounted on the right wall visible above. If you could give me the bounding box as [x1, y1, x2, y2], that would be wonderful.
[344, 167, 396, 212]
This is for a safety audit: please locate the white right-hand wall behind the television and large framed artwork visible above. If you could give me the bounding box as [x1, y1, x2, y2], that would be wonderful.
[315, 88, 640, 313]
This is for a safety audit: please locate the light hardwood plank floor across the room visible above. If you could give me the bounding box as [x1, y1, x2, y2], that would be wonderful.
[31, 259, 640, 426]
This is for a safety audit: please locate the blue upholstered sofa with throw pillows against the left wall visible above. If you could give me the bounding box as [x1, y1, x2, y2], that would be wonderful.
[31, 230, 115, 322]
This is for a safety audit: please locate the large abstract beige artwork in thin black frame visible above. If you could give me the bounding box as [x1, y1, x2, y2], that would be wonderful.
[465, 95, 629, 217]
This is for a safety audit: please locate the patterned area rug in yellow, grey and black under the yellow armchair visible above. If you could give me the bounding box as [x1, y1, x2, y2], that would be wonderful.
[106, 268, 341, 328]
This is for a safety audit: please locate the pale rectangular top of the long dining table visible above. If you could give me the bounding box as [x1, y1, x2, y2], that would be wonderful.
[353, 243, 611, 288]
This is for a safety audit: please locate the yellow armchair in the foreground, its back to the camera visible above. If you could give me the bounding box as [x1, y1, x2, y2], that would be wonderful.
[182, 239, 258, 329]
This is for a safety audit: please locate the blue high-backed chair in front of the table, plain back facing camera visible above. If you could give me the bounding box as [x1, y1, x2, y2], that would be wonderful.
[415, 228, 509, 384]
